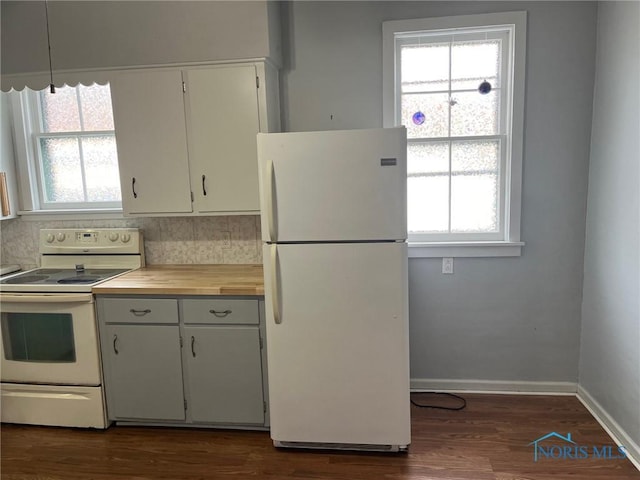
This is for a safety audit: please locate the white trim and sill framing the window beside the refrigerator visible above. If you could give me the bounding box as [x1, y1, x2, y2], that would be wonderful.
[382, 12, 527, 258]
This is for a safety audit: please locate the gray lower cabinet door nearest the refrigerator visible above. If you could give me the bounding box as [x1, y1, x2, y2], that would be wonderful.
[184, 326, 264, 424]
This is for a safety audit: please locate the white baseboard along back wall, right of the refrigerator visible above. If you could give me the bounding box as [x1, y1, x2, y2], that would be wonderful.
[410, 378, 578, 395]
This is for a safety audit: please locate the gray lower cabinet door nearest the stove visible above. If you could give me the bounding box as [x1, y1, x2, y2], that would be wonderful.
[102, 325, 185, 420]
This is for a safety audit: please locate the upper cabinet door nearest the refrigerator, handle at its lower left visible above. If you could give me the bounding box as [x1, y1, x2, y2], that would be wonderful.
[183, 65, 260, 213]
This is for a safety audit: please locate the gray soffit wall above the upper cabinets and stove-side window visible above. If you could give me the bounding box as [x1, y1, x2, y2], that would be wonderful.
[1, 0, 281, 74]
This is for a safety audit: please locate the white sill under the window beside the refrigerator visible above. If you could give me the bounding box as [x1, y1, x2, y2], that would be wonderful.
[409, 242, 524, 258]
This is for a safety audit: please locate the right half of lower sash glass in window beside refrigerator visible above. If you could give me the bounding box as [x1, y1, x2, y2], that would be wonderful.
[451, 140, 500, 232]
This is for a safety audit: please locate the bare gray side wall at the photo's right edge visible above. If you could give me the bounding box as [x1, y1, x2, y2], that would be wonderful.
[580, 2, 640, 444]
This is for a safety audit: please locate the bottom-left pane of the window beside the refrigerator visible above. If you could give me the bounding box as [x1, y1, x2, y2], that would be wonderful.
[407, 174, 449, 233]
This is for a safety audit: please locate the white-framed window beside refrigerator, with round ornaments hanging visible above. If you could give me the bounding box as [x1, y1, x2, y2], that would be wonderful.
[383, 13, 526, 256]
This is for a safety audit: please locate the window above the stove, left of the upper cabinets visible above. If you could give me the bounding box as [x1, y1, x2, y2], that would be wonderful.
[9, 84, 121, 211]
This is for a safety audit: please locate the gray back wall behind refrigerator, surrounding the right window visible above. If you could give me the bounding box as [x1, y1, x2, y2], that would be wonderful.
[282, 2, 596, 382]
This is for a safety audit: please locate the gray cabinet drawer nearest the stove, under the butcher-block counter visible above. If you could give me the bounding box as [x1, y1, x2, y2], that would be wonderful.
[98, 298, 178, 325]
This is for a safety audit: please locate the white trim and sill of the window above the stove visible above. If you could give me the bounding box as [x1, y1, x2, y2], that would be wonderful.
[9, 88, 124, 216]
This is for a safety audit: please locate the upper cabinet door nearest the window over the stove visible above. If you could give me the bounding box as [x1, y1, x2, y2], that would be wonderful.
[111, 69, 192, 214]
